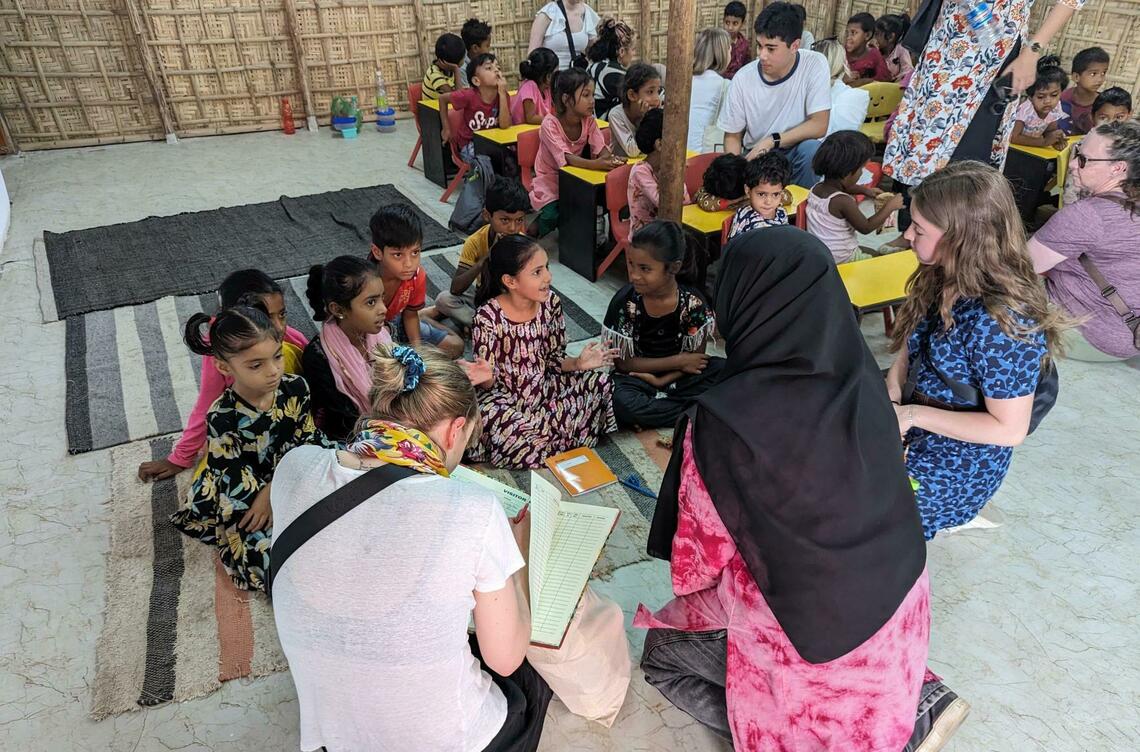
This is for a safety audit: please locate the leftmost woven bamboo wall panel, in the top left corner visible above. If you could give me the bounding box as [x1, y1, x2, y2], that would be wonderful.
[0, 0, 163, 149]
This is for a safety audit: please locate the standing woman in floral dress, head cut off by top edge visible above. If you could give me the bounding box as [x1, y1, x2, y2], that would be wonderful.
[882, 0, 1085, 230]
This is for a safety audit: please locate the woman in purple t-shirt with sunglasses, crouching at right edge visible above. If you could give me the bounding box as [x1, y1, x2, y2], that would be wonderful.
[1029, 120, 1140, 362]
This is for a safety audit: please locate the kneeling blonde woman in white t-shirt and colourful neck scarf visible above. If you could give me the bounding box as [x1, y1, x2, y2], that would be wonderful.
[270, 345, 551, 752]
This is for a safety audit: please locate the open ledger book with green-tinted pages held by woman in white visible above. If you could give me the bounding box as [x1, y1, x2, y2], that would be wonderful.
[451, 466, 620, 647]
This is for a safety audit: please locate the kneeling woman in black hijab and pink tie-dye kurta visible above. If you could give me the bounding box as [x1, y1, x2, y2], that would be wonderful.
[634, 227, 968, 752]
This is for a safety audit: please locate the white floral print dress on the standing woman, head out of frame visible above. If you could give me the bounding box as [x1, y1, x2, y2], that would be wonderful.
[882, 0, 1085, 186]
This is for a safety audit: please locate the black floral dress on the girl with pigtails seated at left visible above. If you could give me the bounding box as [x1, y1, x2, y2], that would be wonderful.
[170, 374, 337, 590]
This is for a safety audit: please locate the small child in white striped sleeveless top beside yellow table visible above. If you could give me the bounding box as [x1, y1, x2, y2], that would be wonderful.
[804, 131, 903, 263]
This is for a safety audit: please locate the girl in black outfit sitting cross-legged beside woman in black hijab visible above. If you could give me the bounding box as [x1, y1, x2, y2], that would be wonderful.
[602, 220, 724, 428]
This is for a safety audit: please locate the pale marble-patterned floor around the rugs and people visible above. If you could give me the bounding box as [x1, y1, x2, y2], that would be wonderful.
[0, 122, 1140, 752]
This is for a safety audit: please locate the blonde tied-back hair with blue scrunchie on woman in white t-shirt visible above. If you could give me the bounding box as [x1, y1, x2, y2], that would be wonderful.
[361, 344, 480, 441]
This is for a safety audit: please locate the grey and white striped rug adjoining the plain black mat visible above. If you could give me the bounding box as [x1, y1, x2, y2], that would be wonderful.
[65, 248, 604, 455]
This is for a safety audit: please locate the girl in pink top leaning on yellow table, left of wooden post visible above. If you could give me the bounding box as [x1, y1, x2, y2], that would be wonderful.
[530, 68, 626, 237]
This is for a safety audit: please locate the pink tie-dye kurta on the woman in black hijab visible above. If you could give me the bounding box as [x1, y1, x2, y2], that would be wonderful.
[634, 427, 930, 752]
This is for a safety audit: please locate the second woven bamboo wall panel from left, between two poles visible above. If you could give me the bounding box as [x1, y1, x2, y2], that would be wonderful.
[140, 0, 306, 134]
